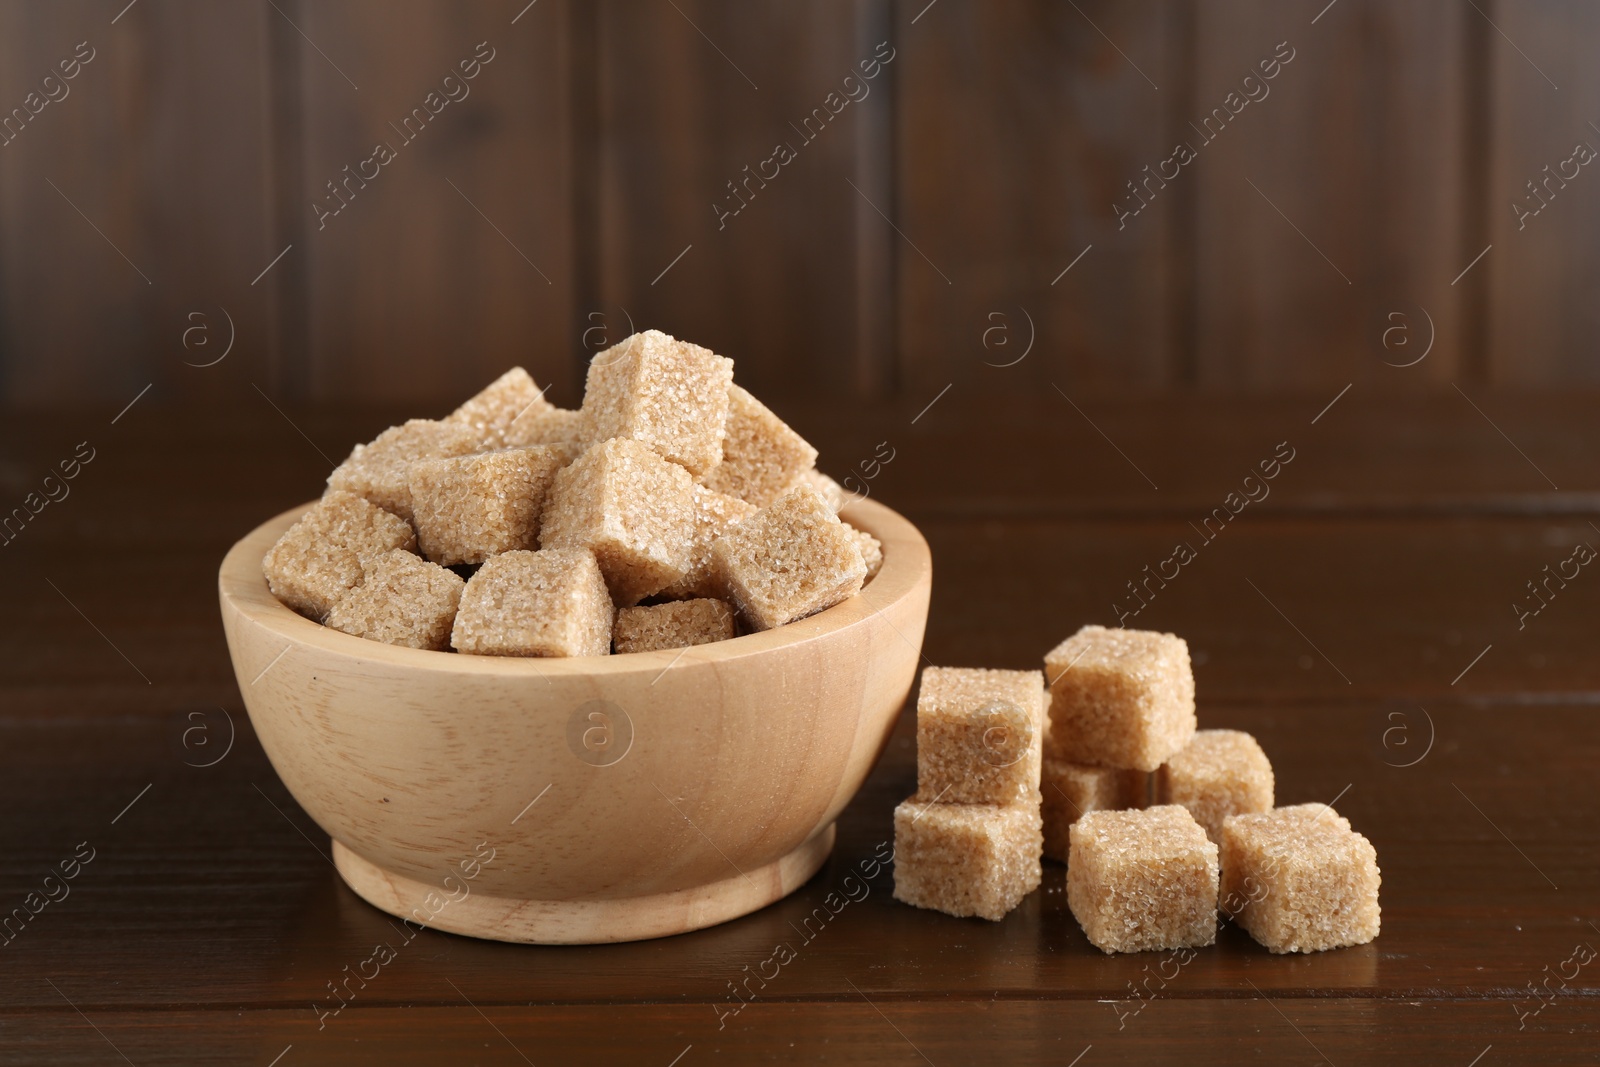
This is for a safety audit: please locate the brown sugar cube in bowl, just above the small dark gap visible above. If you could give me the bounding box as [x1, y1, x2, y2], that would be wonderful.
[411, 446, 566, 565]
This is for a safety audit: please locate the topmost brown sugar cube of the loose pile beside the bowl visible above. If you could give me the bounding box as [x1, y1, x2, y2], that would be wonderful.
[1045, 625, 1195, 771]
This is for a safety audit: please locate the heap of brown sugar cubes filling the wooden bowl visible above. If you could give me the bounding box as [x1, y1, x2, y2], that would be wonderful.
[262, 330, 883, 656]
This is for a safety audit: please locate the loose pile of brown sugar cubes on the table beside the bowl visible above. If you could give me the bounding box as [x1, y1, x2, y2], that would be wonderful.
[894, 625, 1379, 952]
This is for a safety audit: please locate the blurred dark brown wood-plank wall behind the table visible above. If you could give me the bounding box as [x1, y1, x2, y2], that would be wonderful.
[0, 0, 1600, 413]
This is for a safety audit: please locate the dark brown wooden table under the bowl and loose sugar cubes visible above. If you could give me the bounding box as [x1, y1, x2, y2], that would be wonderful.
[0, 384, 1600, 1067]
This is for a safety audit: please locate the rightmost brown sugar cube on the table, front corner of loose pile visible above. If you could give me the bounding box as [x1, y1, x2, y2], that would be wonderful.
[1222, 805, 1382, 952]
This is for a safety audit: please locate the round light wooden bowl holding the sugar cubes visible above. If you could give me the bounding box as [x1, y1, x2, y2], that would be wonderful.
[218, 501, 933, 944]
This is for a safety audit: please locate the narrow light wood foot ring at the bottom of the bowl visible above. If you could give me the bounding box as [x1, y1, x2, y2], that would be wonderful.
[333, 822, 835, 945]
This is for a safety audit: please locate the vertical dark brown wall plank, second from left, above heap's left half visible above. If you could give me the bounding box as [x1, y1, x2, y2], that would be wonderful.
[296, 0, 578, 409]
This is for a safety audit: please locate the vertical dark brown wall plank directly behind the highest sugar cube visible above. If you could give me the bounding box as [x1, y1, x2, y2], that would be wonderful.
[584, 0, 902, 399]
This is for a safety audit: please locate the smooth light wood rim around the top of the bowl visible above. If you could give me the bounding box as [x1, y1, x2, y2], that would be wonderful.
[218, 499, 933, 680]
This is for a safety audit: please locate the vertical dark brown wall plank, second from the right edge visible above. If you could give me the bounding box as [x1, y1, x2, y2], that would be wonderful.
[1190, 0, 1478, 389]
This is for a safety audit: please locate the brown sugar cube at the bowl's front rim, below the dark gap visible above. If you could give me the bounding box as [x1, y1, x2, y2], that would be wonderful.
[450, 549, 611, 656]
